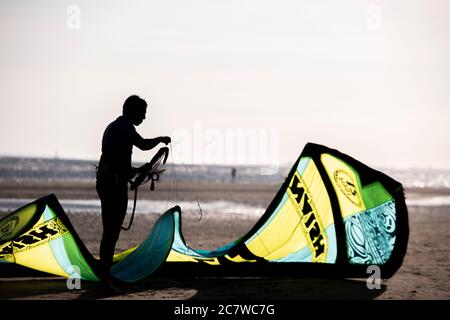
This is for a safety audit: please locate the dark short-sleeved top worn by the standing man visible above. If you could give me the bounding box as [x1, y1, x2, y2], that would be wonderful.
[97, 116, 140, 183]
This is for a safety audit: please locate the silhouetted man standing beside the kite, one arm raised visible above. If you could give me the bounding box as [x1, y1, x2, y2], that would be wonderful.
[96, 95, 171, 289]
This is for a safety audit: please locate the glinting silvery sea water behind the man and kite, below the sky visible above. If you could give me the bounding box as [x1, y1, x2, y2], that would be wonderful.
[0, 157, 450, 217]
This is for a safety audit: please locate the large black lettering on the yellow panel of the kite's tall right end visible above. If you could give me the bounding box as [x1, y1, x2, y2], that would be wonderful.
[288, 173, 326, 261]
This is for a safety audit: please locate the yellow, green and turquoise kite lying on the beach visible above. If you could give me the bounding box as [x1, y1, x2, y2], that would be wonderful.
[0, 143, 409, 282]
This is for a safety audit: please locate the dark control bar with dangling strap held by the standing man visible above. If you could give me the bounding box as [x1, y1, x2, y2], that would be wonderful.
[121, 147, 169, 230]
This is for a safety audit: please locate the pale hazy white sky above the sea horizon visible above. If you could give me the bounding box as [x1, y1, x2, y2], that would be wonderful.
[0, 0, 450, 168]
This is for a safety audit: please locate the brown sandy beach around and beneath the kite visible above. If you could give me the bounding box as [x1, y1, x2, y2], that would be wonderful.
[0, 183, 450, 300]
